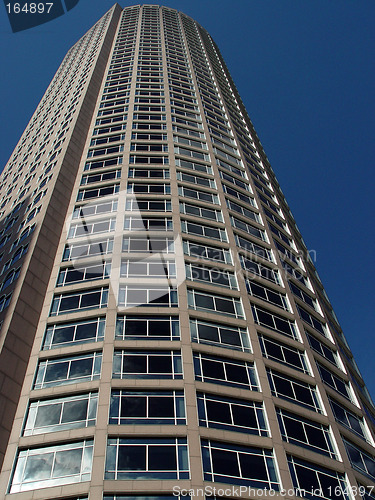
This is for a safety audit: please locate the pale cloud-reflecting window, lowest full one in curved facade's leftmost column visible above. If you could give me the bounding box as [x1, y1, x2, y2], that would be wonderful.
[10, 440, 93, 493]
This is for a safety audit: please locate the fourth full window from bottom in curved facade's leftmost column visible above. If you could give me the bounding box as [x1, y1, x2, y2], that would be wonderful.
[43, 318, 105, 349]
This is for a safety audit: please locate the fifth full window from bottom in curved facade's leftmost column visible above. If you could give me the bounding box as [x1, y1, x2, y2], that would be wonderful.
[50, 288, 108, 316]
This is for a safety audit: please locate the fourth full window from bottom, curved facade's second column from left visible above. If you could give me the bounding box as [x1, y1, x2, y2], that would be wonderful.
[115, 315, 180, 340]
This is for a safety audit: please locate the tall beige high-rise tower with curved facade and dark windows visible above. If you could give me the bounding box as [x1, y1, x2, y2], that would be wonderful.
[0, 5, 375, 500]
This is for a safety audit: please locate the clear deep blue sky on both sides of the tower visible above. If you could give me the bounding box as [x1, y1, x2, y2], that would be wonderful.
[0, 0, 375, 398]
